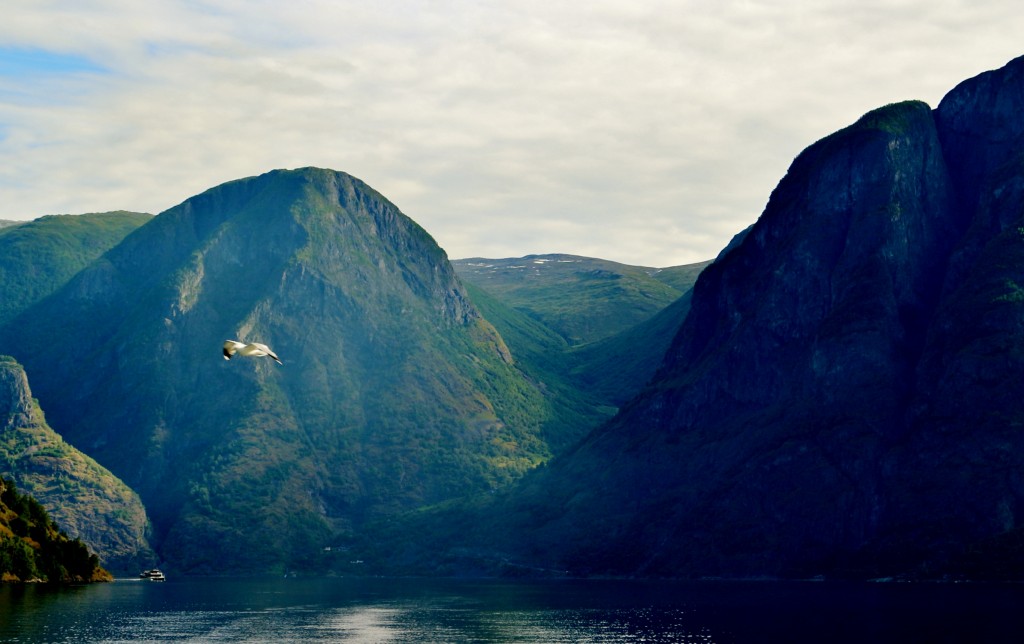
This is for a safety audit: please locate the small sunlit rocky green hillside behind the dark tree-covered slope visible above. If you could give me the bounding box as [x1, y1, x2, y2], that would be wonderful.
[0, 355, 154, 570]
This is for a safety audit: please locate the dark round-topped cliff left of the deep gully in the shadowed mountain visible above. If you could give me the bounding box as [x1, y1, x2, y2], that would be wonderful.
[516, 99, 959, 576]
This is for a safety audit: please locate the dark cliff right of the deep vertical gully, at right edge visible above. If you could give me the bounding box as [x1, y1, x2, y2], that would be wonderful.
[884, 54, 1024, 575]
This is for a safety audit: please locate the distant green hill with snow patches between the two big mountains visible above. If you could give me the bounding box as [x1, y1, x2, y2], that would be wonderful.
[452, 255, 699, 346]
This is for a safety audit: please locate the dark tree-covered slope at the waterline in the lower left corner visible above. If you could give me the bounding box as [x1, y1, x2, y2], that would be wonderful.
[0, 477, 113, 584]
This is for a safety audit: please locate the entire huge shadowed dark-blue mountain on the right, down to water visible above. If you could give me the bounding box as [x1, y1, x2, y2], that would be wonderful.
[380, 54, 1024, 579]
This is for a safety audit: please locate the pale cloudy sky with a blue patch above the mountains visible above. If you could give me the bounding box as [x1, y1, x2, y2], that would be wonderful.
[0, 0, 1024, 267]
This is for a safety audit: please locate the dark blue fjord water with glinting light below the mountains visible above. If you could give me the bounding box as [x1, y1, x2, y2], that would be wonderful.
[0, 578, 1024, 644]
